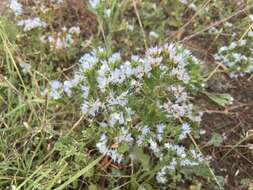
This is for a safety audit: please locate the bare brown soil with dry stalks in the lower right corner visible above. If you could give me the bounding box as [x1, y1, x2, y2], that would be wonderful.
[201, 76, 253, 190]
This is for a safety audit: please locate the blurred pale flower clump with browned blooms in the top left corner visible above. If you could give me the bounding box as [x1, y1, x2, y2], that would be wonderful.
[9, 0, 83, 50]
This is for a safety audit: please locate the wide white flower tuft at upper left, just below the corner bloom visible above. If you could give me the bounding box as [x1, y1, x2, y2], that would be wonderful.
[17, 17, 47, 32]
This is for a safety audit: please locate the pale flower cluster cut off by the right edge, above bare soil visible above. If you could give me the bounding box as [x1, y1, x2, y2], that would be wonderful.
[214, 32, 253, 78]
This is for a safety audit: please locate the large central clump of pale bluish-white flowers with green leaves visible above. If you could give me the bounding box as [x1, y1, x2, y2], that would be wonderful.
[49, 44, 206, 182]
